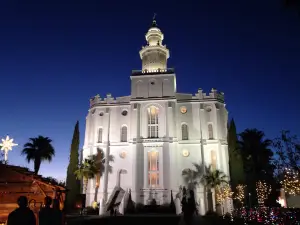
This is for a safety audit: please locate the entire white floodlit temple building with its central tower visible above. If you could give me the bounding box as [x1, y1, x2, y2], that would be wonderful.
[83, 20, 229, 214]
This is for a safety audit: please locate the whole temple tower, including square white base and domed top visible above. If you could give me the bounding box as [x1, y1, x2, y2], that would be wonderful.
[130, 18, 176, 99]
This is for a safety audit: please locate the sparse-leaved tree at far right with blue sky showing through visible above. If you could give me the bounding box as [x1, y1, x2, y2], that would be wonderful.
[273, 130, 300, 176]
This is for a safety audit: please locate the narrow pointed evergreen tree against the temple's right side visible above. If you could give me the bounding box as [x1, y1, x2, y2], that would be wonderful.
[228, 119, 245, 191]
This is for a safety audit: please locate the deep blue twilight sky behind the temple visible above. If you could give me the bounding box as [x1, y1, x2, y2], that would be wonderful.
[0, 0, 300, 179]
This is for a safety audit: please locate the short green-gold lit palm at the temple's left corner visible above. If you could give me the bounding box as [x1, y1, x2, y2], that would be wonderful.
[74, 156, 98, 194]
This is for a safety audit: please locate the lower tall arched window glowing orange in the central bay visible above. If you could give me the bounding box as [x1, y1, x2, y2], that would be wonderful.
[148, 151, 159, 187]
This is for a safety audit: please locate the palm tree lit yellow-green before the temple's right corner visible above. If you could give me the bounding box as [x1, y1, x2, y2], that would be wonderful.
[202, 165, 228, 214]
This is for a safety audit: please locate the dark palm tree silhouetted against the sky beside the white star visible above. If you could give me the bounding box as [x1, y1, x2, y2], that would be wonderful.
[21, 136, 55, 174]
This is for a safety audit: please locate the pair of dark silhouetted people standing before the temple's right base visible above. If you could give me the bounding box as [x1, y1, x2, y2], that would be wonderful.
[181, 187, 197, 225]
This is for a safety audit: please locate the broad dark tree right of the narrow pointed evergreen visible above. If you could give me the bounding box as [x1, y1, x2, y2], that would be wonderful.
[239, 129, 274, 205]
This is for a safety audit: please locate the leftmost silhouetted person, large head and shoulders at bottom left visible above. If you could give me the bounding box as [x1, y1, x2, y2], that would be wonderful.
[7, 196, 36, 225]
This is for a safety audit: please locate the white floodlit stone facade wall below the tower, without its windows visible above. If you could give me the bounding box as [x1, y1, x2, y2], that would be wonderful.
[83, 86, 229, 211]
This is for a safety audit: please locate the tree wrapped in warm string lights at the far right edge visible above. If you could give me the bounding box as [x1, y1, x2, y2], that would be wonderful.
[280, 168, 300, 195]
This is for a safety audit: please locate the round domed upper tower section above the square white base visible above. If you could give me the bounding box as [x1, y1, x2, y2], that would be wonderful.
[140, 17, 170, 72]
